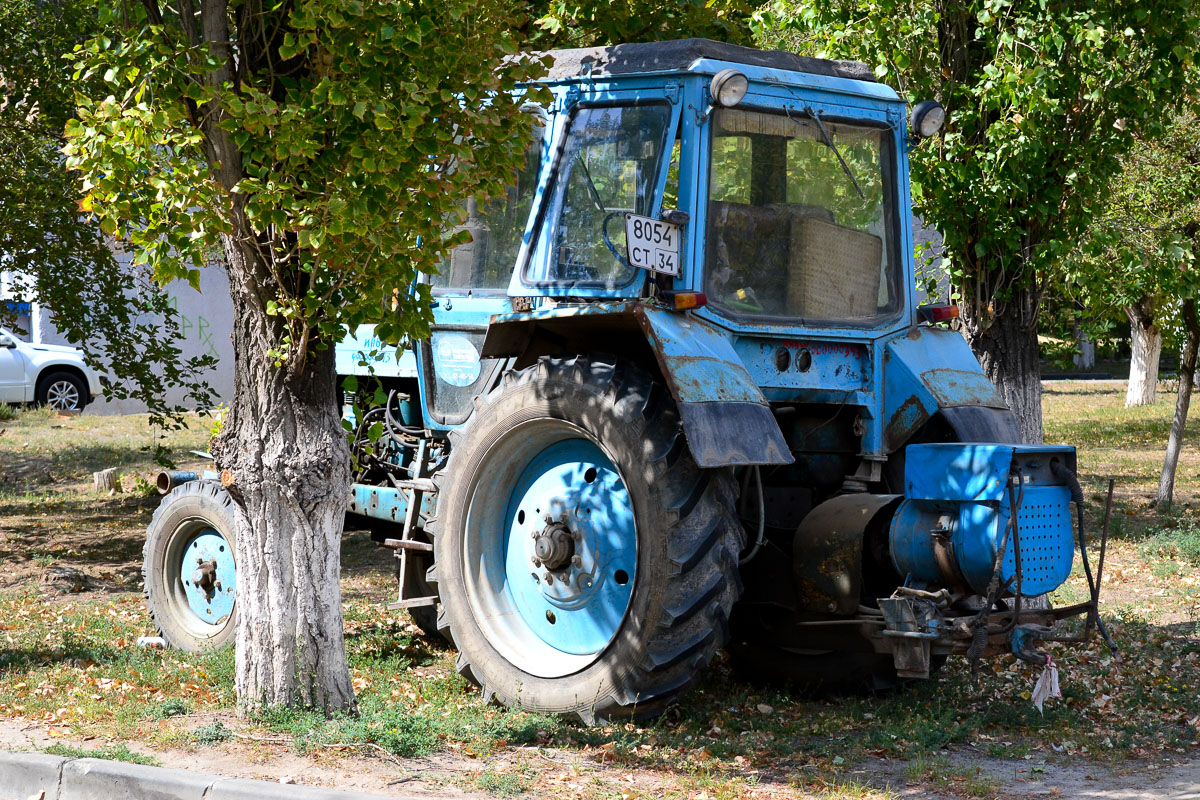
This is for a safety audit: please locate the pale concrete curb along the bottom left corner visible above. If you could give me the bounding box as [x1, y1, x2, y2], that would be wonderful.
[0, 751, 410, 800]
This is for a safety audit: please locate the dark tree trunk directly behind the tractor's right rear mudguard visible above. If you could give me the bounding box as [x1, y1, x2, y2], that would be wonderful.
[960, 288, 1042, 444]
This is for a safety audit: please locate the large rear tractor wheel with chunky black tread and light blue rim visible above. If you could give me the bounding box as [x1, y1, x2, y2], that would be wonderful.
[427, 357, 744, 723]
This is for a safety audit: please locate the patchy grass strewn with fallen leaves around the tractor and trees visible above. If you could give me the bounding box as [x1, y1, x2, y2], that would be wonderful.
[0, 384, 1200, 800]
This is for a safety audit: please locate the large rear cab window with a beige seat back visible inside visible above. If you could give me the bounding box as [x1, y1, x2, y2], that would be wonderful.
[706, 108, 900, 325]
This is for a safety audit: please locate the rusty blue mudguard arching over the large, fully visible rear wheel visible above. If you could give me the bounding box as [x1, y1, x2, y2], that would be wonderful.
[482, 302, 794, 468]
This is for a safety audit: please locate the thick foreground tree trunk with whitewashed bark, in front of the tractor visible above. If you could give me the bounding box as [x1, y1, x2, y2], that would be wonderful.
[212, 239, 355, 714]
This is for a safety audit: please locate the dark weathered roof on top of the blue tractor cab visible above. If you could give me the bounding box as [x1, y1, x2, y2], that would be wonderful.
[546, 38, 876, 83]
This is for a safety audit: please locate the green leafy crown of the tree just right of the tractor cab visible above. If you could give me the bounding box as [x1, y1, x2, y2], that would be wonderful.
[757, 0, 1198, 331]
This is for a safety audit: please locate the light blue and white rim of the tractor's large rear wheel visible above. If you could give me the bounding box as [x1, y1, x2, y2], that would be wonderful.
[463, 420, 637, 678]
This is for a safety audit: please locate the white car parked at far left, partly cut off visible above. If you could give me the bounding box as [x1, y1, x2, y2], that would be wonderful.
[0, 327, 104, 411]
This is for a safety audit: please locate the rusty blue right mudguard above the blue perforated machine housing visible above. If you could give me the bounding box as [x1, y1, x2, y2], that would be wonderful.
[883, 327, 1019, 452]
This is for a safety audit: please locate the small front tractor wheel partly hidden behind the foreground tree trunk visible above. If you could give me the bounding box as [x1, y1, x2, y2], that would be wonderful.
[142, 481, 238, 652]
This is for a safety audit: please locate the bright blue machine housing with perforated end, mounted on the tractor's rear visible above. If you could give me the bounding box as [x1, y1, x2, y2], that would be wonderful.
[889, 444, 1075, 596]
